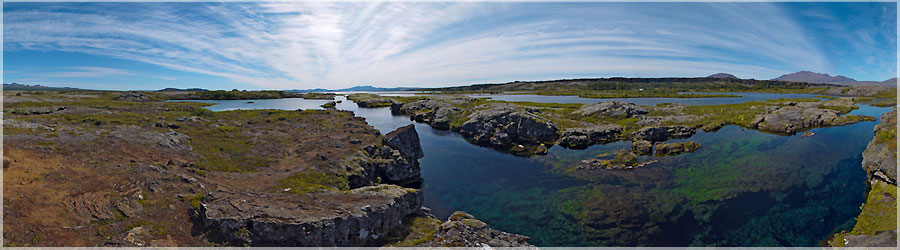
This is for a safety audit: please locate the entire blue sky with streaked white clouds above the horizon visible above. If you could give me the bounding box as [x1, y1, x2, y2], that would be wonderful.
[3, 3, 897, 89]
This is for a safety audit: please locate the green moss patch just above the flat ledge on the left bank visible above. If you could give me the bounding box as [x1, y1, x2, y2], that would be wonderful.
[274, 172, 350, 194]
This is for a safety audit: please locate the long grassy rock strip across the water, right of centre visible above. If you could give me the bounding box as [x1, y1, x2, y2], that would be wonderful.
[354, 94, 875, 159]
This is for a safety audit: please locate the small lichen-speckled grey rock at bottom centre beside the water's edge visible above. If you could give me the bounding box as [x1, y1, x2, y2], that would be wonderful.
[424, 211, 534, 247]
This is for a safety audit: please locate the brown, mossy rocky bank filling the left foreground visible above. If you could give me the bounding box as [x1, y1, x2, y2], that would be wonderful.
[3, 92, 530, 247]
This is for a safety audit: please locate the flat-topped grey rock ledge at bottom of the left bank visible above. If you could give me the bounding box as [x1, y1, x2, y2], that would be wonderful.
[197, 184, 422, 247]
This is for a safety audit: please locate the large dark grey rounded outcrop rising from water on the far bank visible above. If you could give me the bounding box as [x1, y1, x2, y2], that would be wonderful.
[455, 104, 559, 149]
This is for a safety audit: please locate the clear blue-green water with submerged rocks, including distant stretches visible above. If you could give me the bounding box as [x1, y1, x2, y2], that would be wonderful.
[193, 93, 889, 246]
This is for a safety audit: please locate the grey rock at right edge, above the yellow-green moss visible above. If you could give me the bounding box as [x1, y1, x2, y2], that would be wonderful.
[862, 107, 897, 185]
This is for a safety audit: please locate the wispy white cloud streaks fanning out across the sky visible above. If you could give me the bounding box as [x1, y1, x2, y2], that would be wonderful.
[4, 3, 856, 89]
